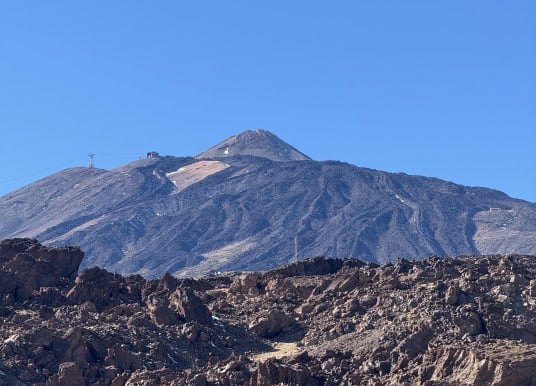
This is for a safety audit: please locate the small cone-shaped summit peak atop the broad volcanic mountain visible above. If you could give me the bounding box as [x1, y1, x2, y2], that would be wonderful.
[196, 130, 310, 161]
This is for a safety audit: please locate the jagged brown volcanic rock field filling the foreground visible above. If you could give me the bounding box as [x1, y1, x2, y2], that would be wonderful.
[0, 239, 536, 386]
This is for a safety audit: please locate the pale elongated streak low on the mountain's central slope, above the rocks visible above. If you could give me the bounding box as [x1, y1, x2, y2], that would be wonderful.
[176, 238, 257, 277]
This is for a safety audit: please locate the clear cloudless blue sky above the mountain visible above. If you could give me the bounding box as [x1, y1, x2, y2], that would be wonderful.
[0, 0, 536, 201]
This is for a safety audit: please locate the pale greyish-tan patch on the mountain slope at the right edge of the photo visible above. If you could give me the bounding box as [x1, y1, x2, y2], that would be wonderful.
[473, 208, 536, 255]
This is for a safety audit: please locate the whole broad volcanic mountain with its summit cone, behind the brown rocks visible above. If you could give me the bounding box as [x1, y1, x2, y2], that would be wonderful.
[0, 131, 536, 277]
